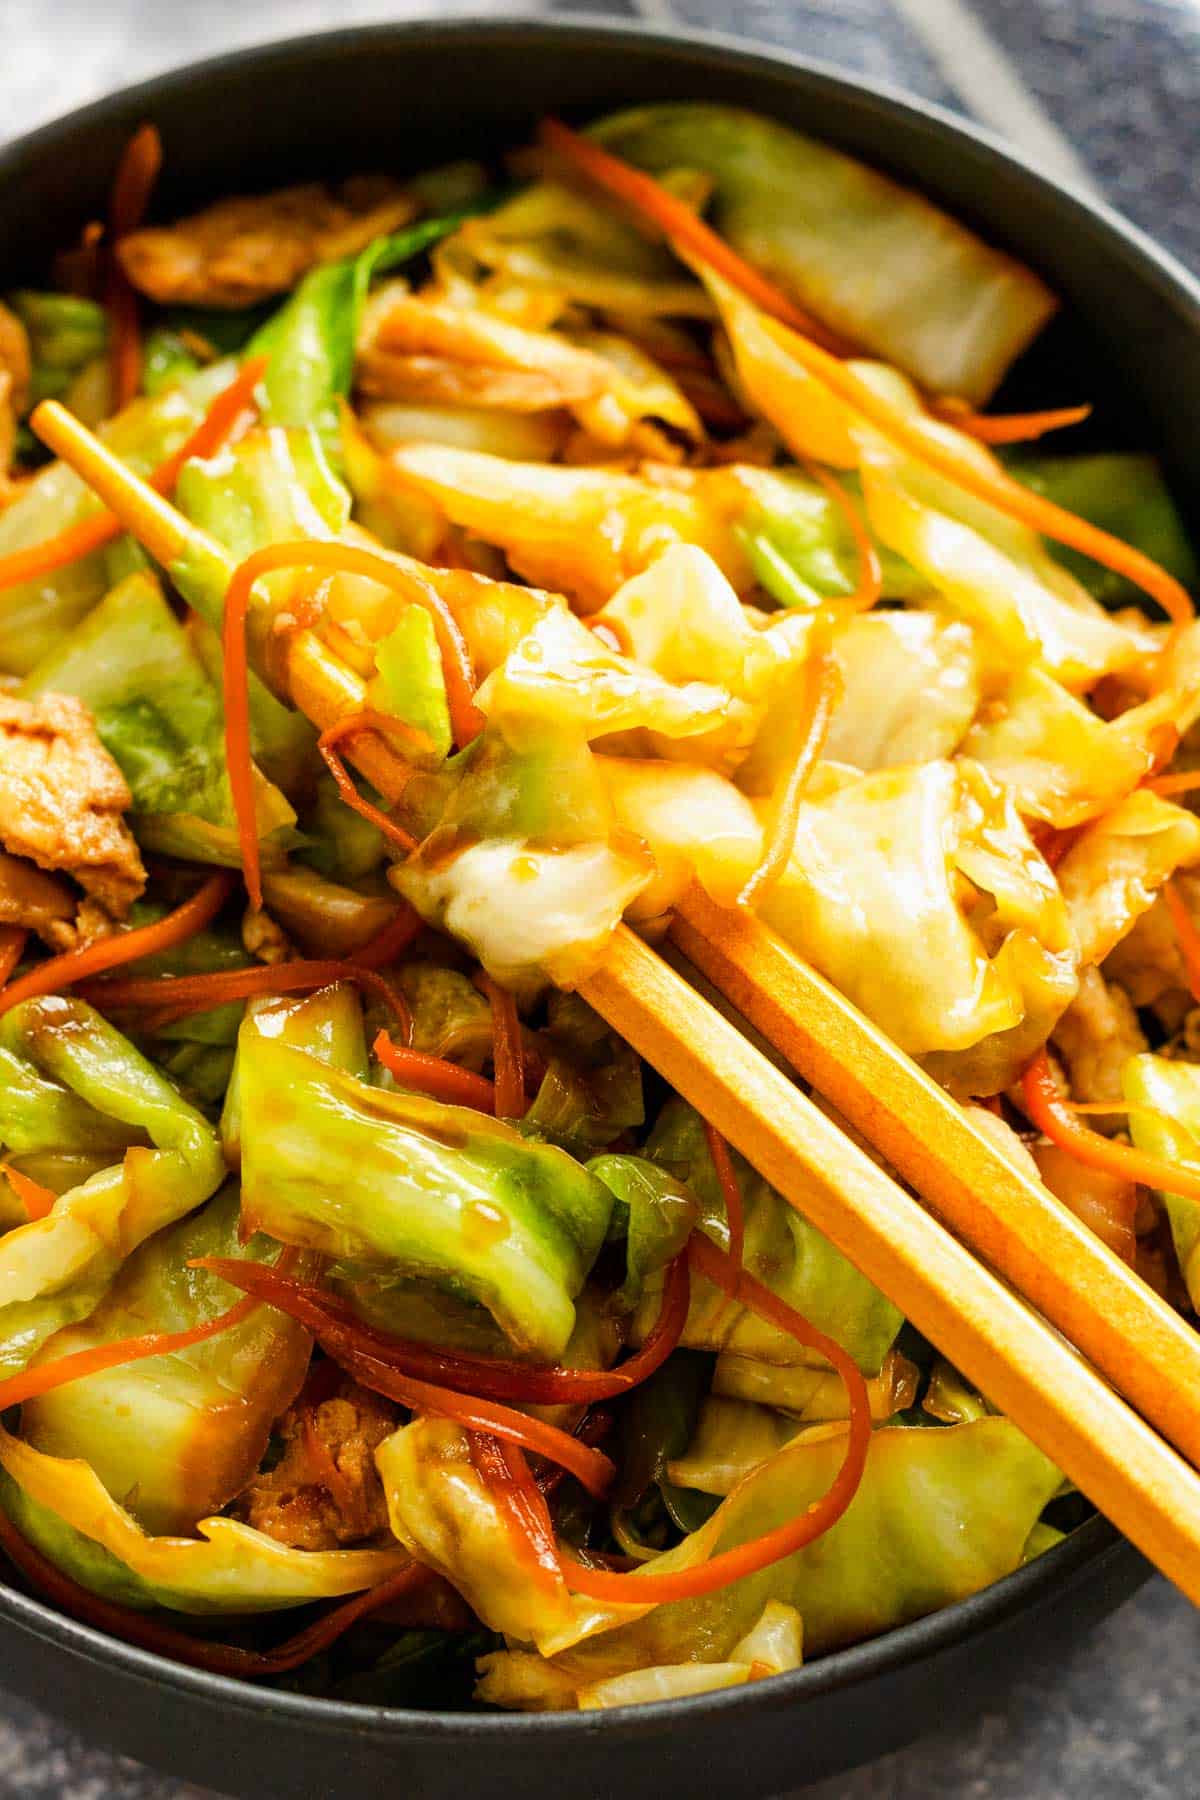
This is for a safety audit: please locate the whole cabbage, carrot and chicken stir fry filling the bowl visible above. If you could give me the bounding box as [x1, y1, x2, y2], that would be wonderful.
[0, 104, 1200, 1708]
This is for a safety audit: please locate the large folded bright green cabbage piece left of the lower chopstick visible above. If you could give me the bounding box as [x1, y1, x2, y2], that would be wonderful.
[237, 1021, 612, 1361]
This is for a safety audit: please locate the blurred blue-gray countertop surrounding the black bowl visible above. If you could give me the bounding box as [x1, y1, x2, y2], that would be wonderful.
[0, 0, 1200, 1800]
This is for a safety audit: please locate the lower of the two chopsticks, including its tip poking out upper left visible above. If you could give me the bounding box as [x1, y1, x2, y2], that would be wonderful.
[36, 403, 1200, 1602]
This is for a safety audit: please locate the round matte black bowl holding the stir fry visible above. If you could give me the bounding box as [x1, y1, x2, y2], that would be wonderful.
[0, 20, 1180, 1800]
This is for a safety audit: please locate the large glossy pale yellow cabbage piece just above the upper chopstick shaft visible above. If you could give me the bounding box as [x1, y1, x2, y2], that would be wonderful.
[763, 761, 1076, 1094]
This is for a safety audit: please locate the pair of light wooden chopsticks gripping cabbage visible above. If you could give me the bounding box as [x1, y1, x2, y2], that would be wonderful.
[36, 401, 1200, 1602]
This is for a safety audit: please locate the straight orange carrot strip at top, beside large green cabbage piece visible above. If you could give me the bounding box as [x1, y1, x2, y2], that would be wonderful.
[540, 119, 851, 353]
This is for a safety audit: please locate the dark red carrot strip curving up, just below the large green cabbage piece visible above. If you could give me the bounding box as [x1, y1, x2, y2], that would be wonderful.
[192, 1253, 691, 1406]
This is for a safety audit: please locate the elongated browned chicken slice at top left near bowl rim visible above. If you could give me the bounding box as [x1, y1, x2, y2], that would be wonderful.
[117, 175, 417, 308]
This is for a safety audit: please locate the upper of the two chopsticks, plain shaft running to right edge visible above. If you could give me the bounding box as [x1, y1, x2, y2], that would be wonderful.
[671, 886, 1200, 1463]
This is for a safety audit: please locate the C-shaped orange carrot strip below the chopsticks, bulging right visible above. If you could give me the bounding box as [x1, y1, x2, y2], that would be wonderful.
[563, 1231, 871, 1606]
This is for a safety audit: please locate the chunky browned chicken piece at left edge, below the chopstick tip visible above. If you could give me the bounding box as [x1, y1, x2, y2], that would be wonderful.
[0, 693, 146, 918]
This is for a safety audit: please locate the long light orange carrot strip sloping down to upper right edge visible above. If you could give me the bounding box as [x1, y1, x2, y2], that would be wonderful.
[763, 319, 1195, 626]
